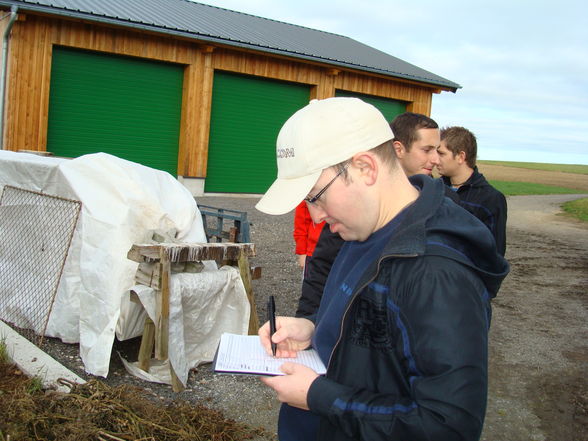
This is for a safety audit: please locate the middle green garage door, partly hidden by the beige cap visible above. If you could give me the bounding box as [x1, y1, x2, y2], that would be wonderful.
[204, 71, 310, 193]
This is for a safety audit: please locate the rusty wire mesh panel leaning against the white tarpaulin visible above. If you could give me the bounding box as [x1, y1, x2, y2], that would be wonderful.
[0, 185, 82, 346]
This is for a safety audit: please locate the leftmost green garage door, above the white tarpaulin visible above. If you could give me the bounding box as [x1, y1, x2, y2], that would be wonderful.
[47, 47, 183, 176]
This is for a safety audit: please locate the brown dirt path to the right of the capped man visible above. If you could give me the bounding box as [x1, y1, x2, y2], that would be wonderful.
[482, 195, 588, 441]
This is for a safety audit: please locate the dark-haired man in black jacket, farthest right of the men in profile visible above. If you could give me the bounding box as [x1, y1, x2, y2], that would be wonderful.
[437, 127, 507, 256]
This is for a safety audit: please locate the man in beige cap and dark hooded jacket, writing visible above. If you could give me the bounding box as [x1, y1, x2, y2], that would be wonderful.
[257, 98, 508, 441]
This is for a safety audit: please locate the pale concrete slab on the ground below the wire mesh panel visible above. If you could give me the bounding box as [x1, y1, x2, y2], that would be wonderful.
[0, 321, 86, 392]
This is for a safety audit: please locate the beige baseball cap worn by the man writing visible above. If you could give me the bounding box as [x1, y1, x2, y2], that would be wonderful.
[255, 97, 394, 214]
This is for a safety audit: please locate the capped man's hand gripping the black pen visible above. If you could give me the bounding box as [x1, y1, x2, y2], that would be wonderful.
[258, 317, 314, 358]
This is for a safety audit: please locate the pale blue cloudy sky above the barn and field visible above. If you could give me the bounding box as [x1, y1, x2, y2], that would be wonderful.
[194, 0, 588, 164]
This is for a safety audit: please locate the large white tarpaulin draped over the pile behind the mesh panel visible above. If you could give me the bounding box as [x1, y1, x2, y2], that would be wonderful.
[0, 151, 249, 376]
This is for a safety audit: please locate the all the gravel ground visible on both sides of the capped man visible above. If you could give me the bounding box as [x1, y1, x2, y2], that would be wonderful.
[44, 195, 588, 441]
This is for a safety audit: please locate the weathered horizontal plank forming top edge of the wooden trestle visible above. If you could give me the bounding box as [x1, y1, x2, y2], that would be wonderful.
[127, 242, 255, 262]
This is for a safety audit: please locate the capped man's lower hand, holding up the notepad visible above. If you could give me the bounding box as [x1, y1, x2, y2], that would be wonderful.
[261, 362, 319, 410]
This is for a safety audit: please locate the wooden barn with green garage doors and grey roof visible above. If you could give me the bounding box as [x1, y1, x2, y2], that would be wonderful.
[0, 0, 460, 195]
